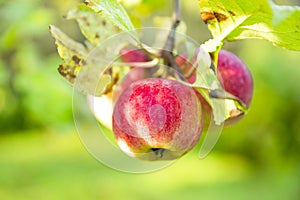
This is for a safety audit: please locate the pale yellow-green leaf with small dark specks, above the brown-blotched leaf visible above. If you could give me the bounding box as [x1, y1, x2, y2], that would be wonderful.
[67, 4, 120, 45]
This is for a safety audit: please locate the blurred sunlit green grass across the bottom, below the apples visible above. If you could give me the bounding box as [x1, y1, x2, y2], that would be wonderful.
[0, 130, 300, 200]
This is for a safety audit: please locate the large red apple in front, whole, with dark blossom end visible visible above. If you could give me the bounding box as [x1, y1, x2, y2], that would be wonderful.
[113, 78, 203, 160]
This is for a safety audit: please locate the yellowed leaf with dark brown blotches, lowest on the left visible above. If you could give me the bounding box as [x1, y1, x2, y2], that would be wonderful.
[50, 26, 111, 96]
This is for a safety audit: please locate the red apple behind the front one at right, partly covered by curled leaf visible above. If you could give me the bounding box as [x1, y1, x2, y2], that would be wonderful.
[176, 49, 253, 127]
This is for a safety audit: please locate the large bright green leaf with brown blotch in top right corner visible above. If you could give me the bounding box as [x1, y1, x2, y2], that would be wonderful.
[199, 0, 300, 51]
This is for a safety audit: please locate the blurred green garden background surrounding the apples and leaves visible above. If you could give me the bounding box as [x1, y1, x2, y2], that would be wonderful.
[0, 0, 300, 200]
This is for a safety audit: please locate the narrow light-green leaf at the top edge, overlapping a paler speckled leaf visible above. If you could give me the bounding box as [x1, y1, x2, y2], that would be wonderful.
[86, 0, 138, 40]
